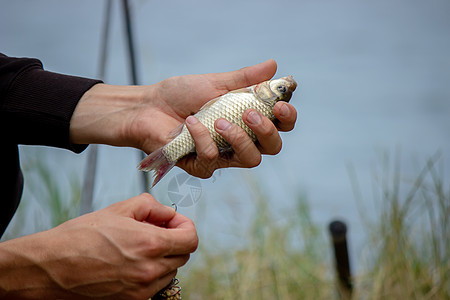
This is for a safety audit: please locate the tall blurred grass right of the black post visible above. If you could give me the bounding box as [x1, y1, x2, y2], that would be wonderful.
[348, 154, 450, 299]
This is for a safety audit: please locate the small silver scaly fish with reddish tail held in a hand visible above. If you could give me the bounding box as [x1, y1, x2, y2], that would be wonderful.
[138, 76, 297, 186]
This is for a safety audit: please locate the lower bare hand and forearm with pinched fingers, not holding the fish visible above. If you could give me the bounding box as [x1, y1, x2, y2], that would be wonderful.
[0, 194, 198, 299]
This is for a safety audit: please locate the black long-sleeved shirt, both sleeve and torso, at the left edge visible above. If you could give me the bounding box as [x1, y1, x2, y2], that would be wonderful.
[0, 54, 101, 237]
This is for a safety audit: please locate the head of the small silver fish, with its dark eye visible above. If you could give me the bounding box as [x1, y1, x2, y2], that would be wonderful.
[254, 75, 297, 102]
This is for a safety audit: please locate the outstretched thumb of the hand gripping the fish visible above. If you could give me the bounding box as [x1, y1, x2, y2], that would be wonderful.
[214, 59, 277, 93]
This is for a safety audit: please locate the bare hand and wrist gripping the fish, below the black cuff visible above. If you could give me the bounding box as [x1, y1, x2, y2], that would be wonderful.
[71, 60, 297, 182]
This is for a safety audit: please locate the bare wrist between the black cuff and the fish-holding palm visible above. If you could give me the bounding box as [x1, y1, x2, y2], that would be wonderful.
[70, 84, 153, 146]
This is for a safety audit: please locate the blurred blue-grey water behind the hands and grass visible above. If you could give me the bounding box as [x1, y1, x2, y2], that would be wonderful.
[0, 0, 450, 298]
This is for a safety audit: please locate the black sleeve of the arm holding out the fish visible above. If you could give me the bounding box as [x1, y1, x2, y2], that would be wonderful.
[0, 54, 101, 152]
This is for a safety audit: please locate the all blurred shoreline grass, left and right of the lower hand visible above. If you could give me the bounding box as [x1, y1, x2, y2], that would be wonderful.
[4, 151, 450, 300]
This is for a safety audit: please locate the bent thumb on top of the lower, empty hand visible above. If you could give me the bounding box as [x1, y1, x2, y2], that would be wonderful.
[105, 193, 176, 224]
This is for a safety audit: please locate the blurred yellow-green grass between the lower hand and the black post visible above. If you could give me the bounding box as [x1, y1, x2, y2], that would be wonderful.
[179, 192, 335, 299]
